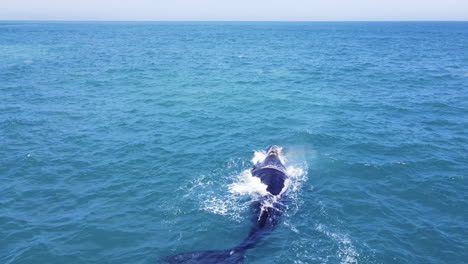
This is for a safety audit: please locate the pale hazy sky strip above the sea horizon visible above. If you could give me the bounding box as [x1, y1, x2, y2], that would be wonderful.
[0, 0, 468, 21]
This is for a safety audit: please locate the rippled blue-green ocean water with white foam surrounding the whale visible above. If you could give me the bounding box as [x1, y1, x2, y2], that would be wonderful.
[0, 21, 468, 264]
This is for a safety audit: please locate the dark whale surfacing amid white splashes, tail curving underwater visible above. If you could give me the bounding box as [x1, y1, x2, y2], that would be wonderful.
[163, 145, 288, 264]
